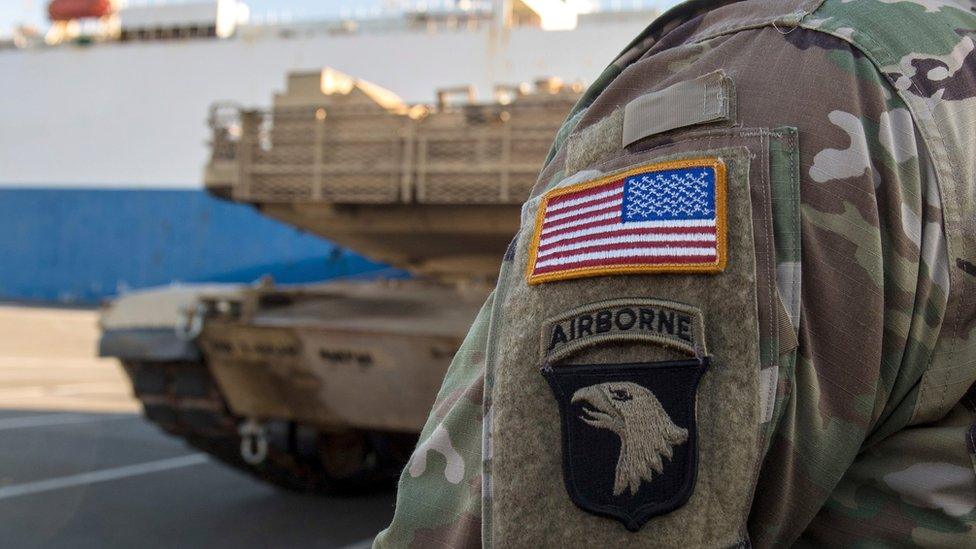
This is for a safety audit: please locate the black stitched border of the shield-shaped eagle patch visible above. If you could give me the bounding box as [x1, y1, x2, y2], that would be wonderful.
[542, 356, 711, 532]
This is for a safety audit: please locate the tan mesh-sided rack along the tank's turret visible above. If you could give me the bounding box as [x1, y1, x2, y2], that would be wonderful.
[207, 105, 569, 204]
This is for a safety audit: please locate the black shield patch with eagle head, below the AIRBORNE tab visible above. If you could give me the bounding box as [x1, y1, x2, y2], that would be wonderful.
[543, 357, 709, 531]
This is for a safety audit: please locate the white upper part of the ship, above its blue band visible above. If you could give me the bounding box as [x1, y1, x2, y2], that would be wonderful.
[0, 0, 655, 188]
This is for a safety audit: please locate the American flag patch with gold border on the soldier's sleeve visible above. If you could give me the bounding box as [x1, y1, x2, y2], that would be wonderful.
[528, 158, 727, 284]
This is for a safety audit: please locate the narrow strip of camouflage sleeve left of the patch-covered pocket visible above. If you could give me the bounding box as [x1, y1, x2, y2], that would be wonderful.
[373, 296, 493, 548]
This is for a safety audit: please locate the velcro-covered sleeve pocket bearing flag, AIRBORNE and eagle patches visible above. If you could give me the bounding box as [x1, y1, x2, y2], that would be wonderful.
[489, 128, 799, 546]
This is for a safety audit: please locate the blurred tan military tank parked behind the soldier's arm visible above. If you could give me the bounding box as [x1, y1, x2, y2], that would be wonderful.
[100, 69, 581, 493]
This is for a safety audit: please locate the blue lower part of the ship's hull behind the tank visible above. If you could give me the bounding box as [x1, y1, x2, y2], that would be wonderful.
[0, 188, 402, 305]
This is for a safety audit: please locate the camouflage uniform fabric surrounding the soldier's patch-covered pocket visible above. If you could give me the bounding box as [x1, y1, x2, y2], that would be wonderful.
[376, 0, 976, 547]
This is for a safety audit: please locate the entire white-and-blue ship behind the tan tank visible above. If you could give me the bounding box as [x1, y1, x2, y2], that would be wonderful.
[0, 0, 655, 303]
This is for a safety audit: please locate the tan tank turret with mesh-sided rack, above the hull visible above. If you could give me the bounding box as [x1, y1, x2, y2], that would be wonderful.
[205, 69, 580, 280]
